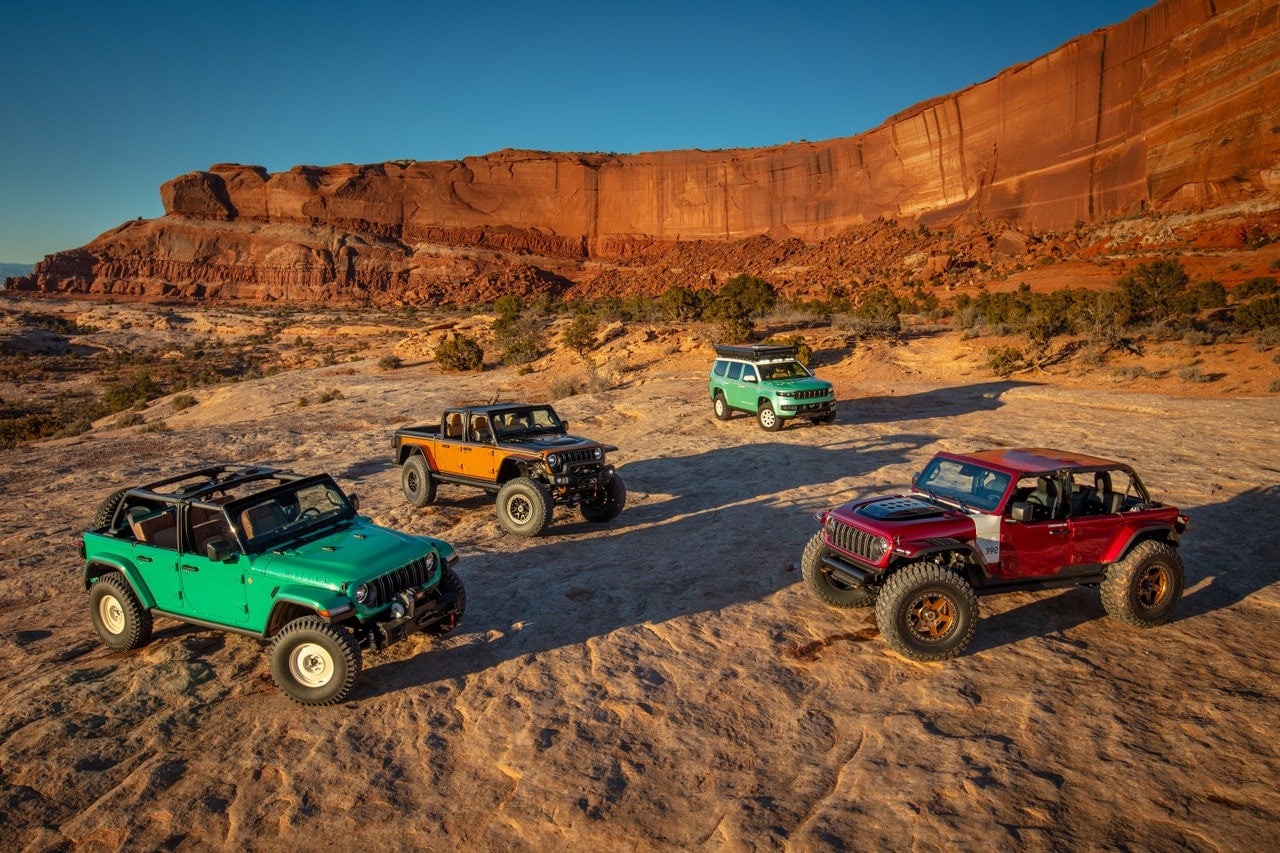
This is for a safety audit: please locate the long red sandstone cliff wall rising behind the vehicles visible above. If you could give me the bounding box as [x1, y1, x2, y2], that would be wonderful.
[10, 0, 1280, 301]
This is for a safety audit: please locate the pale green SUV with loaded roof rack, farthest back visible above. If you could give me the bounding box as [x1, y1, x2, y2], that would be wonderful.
[710, 345, 836, 433]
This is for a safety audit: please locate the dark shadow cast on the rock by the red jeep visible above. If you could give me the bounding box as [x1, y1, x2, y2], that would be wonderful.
[965, 485, 1280, 654]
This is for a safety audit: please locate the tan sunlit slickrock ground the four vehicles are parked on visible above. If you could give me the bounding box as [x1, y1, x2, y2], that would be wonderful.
[0, 313, 1280, 850]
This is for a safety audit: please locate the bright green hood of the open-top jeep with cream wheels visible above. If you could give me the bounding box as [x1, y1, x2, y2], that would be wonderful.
[253, 520, 453, 589]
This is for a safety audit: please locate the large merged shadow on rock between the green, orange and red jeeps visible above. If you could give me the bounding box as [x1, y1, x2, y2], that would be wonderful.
[355, 434, 934, 698]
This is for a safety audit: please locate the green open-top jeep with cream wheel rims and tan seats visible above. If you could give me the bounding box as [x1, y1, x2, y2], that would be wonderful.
[82, 465, 466, 704]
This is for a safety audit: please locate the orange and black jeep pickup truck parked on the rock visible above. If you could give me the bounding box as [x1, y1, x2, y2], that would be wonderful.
[392, 403, 627, 537]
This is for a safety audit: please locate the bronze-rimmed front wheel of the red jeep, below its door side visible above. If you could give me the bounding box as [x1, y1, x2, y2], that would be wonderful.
[876, 562, 978, 661]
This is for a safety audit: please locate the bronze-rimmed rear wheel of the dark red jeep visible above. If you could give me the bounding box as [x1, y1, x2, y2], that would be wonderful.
[1098, 539, 1185, 628]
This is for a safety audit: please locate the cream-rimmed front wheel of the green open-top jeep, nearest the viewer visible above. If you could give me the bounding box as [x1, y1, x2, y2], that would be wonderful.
[271, 616, 360, 704]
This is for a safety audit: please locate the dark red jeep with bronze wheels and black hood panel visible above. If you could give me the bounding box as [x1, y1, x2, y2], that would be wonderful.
[801, 448, 1188, 661]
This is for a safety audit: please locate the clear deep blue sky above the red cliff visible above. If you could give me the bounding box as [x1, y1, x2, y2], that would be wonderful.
[0, 0, 1152, 263]
